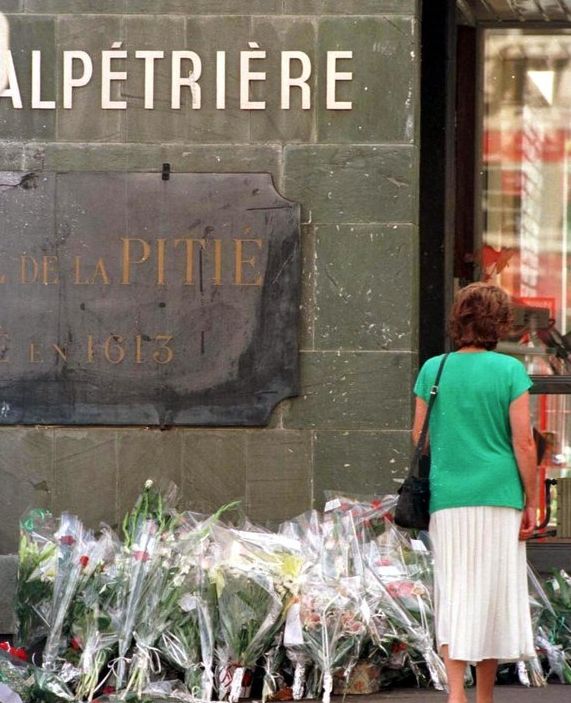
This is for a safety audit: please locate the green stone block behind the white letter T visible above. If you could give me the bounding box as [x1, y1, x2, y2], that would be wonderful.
[124, 15, 189, 143]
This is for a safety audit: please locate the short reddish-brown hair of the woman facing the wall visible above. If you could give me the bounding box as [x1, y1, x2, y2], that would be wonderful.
[449, 283, 513, 350]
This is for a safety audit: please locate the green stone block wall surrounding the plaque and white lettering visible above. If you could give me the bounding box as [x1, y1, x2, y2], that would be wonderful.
[0, 0, 419, 553]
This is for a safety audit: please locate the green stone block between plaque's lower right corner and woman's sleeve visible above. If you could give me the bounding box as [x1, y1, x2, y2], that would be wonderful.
[283, 352, 413, 430]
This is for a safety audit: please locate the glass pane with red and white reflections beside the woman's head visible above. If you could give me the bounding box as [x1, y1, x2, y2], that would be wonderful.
[475, 29, 571, 525]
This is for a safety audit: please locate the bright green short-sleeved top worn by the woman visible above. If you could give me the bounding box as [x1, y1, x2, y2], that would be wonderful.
[414, 351, 532, 513]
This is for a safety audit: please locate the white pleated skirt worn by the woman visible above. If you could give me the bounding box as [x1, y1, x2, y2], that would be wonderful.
[430, 506, 535, 664]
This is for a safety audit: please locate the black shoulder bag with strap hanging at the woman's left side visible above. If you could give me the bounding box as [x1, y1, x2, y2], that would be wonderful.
[395, 354, 449, 530]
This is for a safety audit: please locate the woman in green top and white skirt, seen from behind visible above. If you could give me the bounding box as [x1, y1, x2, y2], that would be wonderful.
[413, 283, 537, 703]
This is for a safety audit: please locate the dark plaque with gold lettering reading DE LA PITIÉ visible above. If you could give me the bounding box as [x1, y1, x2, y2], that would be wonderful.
[0, 173, 300, 426]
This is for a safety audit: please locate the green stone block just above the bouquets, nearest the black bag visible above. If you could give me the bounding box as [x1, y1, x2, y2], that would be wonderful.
[313, 430, 411, 509]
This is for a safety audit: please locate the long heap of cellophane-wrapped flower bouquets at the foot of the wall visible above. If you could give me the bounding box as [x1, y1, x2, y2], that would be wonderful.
[4, 481, 571, 703]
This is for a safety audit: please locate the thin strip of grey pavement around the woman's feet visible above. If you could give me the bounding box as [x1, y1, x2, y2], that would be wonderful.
[338, 683, 571, 703]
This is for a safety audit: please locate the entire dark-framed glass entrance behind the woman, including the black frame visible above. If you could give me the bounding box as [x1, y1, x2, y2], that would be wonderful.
[420, 0, 571, 568]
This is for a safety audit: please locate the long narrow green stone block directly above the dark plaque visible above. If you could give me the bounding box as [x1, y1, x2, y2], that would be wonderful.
[24, 143, 281, 176]
